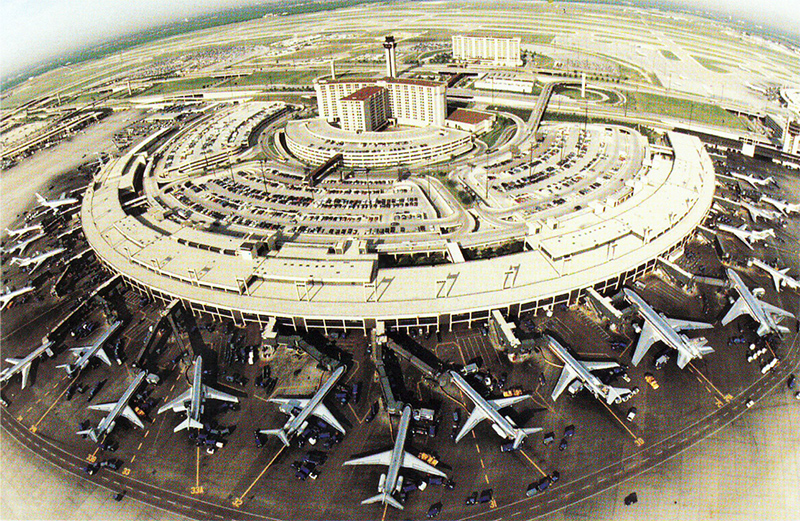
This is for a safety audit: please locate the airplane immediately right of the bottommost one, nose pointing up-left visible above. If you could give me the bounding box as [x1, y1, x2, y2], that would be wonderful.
[450, 371, 542, 449]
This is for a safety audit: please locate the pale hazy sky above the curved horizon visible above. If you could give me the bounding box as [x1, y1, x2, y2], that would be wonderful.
[0, 0, 800, 76]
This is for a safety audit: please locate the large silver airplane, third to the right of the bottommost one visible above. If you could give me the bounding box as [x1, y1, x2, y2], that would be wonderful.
[622, 288, 714, 369]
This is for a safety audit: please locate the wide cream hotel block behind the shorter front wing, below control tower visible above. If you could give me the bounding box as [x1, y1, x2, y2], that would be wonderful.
[314, 77, 447, 129]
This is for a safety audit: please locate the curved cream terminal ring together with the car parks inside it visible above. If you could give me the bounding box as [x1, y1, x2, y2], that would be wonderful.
[82, 89, 714, 331]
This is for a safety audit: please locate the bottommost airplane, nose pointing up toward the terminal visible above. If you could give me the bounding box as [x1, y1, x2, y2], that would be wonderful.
[344, 405, 447, 510]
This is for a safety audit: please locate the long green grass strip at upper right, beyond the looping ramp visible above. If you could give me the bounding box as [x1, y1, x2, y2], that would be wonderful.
[628, 92, 747, 130]
